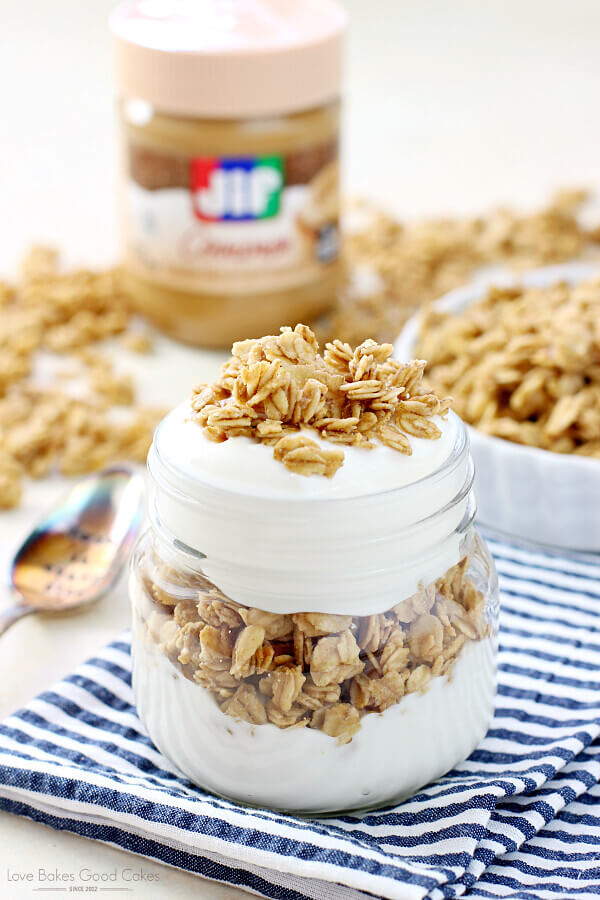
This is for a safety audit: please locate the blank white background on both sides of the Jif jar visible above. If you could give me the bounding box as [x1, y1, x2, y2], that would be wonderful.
[0, 0, 600, 264]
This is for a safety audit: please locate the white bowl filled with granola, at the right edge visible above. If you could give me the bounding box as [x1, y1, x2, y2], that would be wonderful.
[395, 263, 600, 552]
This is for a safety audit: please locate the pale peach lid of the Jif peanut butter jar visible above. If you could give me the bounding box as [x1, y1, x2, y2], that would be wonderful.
[110, 0, 347, 118]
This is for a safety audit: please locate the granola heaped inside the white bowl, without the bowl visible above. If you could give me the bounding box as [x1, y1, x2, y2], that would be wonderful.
[419, 279, 600, 459]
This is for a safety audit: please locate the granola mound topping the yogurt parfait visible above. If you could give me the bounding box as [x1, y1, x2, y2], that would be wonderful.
[192, 325, 449, 477]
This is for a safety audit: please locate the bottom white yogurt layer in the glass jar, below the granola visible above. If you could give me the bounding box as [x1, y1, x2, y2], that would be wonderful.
[133, 608, 495, 814]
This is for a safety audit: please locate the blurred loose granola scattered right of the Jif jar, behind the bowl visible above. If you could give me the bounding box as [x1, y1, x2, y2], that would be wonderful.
[324, 190, 600, 344]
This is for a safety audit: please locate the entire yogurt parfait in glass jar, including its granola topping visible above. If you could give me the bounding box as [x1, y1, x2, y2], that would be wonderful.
[130, 325, 498, 815]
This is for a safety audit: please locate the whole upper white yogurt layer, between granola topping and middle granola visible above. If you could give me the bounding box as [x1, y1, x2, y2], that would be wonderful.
[148, 404, 472, 615]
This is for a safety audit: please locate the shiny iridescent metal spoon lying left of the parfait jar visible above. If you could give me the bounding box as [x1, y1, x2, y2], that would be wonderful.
[0, 466, 144, 634]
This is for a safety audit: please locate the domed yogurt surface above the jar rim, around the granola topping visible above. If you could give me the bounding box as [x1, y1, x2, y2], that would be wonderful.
[156, 403, 459, 500]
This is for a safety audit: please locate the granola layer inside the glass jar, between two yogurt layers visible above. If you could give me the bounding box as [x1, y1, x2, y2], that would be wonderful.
[146, 557, 489, 744]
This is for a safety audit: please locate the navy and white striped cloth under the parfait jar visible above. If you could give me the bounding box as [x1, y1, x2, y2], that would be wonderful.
[0, 541, 600, 900]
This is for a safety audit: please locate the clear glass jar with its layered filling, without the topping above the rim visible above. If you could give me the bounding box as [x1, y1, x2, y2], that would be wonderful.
[130, 414, 498, 815]
